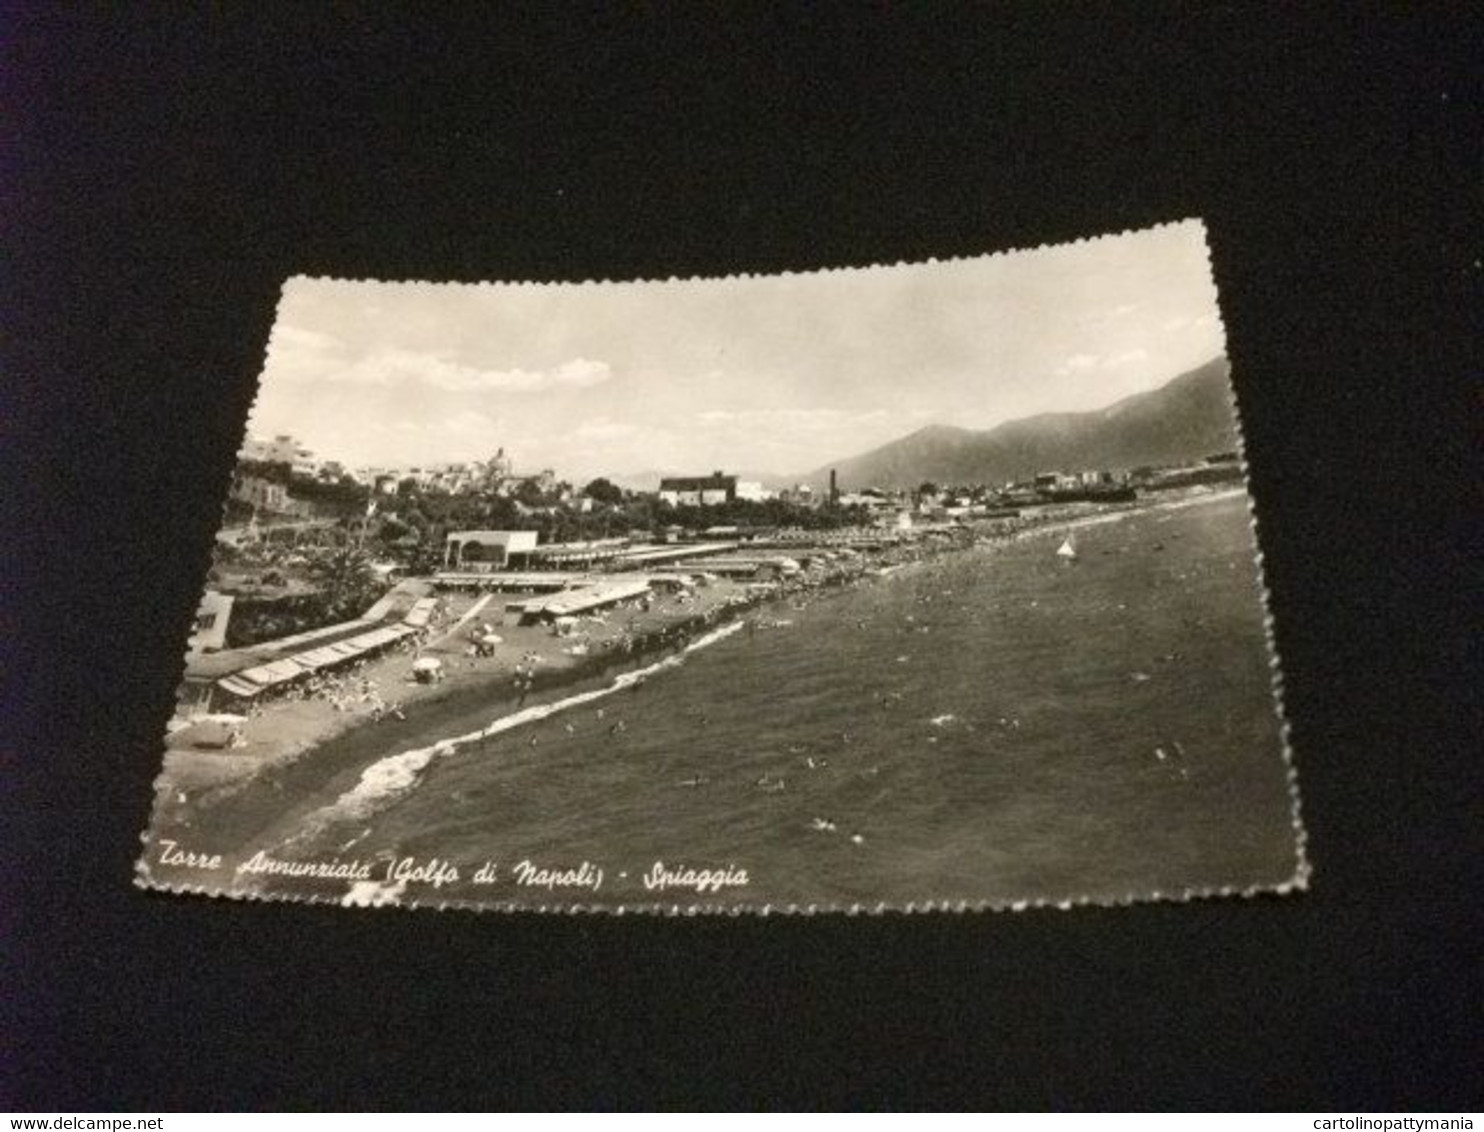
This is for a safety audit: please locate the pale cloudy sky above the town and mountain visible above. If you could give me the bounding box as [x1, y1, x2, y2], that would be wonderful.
[248, 221, 1223, 482]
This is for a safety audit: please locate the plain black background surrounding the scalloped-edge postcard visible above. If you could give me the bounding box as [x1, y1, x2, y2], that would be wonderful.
[0, 3, 1484, 1111]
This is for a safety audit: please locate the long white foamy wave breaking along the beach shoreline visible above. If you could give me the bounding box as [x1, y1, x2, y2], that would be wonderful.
[277, 622, 742, 846]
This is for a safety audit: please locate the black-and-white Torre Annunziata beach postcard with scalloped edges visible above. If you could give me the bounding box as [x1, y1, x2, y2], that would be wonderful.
[138, 221, 1307, 911]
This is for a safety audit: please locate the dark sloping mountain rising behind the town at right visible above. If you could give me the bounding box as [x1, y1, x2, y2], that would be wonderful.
[798, 358, 1236, 491]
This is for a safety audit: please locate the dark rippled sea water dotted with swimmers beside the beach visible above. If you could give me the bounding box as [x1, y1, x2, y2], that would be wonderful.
[219, 496, 1296, 906]
